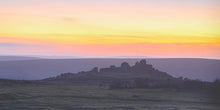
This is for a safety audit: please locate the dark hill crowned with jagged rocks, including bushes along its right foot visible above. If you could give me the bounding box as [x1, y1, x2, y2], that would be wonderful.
[42, 60, 215, 91]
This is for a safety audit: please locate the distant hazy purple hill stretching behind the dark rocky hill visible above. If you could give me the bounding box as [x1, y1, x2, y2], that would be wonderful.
[0, 58, 220, 81]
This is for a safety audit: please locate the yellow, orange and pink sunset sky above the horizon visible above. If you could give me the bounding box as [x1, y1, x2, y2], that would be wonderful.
[0, 0, 220, 59]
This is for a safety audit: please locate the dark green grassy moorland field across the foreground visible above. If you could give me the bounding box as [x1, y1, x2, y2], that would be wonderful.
[0, 84, 220, 110]
